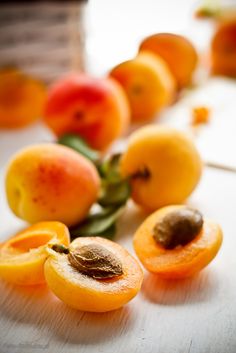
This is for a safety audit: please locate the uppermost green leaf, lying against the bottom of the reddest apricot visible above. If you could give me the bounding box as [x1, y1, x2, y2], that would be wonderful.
[57, 134, 101, 164]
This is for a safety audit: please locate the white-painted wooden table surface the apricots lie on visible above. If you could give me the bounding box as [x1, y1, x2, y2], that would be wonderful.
[0, 0, 236, 353]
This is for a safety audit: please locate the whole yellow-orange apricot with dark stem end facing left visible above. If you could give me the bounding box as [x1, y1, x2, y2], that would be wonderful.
[120, 125, 202, 211]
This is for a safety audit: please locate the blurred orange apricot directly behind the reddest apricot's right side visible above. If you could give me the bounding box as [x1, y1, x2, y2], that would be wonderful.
[110, 52, 175, 122]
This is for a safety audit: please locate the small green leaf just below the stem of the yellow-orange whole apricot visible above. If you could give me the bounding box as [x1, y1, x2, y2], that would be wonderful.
[98, 179, 131, 207]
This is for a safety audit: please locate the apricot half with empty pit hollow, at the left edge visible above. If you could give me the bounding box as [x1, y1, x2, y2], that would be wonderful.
[0, 222, 70, 285]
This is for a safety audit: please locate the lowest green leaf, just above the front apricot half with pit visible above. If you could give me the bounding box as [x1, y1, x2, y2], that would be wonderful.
[70, 206, 124, 238]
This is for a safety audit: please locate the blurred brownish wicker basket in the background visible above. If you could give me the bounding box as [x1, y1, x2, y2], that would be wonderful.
[0, 1, 85, 83]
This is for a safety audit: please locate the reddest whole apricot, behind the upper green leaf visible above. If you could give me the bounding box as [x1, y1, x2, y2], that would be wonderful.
[44, 74, 130, 150]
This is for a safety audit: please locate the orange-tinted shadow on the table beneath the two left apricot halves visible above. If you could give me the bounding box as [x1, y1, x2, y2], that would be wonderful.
[0, 282, 135, 345]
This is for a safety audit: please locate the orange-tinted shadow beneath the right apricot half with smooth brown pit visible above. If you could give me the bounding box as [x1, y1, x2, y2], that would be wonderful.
[141, 270, 219, 305]
